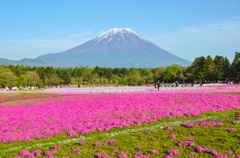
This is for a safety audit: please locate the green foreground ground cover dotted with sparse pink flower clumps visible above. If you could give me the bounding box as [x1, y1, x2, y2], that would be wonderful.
[2, 109, 240, 158]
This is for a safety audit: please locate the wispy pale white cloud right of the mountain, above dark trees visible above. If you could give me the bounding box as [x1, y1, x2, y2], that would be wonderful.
[147, 20, 240, 61]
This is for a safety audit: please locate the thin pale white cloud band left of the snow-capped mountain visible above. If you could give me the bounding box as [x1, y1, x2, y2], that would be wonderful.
[0, 31, 95, 60]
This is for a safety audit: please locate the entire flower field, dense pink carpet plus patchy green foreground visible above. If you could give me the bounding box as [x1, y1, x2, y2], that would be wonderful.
[0, 87, 240, 158]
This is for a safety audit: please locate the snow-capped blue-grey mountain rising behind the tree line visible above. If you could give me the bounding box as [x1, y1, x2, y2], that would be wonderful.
[0, 28, 191, 68]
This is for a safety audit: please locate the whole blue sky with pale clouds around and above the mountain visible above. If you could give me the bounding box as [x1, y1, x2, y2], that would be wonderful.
[0, 0, 240, 61]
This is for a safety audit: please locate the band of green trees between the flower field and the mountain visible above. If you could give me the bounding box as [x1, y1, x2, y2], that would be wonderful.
[0, 52, 240, 88]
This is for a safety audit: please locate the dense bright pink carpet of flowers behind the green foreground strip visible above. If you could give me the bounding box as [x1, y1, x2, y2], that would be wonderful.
[0, 92, 240, 143]
